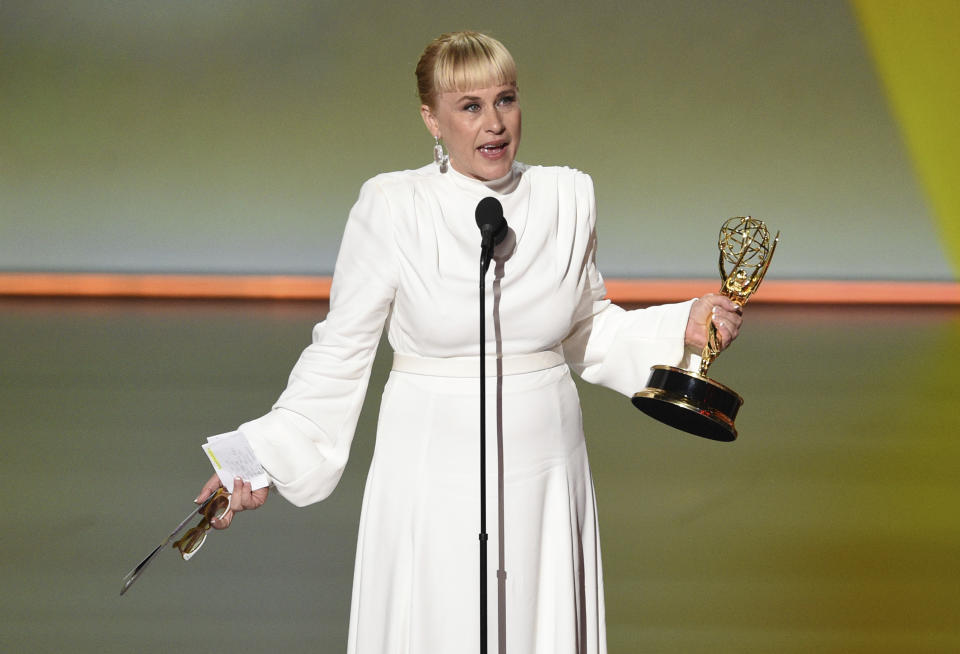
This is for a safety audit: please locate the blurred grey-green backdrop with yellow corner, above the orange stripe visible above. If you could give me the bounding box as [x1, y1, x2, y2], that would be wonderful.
[0, 0, 960, 280]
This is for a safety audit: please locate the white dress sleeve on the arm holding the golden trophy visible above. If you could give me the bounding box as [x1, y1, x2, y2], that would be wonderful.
[563, 175, 693, 397]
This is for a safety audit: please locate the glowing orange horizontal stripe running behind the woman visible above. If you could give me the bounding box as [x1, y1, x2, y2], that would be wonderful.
[0, 273, 960, 306]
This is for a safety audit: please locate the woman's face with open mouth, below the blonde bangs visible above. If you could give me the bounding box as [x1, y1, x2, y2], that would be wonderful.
[420, 84, 520, 181]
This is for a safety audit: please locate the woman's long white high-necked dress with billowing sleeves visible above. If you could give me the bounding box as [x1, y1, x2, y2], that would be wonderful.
[241, 163, 689, 654]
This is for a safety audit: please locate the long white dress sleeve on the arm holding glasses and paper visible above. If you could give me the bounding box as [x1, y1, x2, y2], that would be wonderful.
[240, 179, 397, 506]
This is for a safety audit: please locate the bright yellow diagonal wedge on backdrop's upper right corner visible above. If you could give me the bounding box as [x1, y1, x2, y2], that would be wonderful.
[851, 0, 960, 277]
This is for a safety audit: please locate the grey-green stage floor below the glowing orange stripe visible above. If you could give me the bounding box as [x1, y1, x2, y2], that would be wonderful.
[0, 300, 960, 654]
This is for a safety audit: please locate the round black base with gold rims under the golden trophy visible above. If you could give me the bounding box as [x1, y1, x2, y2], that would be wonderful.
[632, 366, 743, 442]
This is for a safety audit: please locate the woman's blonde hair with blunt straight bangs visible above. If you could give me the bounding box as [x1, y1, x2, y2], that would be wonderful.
[416, 31, 517, 108]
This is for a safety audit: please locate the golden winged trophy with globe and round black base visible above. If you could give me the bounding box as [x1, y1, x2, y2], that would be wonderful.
[632, 216, 780, 441]
